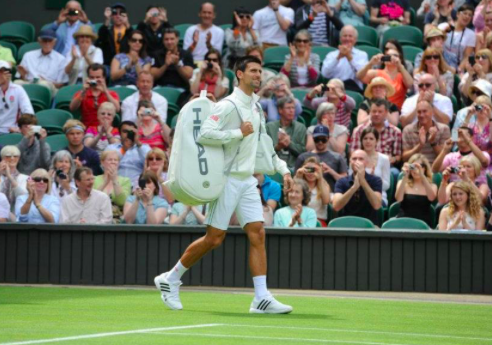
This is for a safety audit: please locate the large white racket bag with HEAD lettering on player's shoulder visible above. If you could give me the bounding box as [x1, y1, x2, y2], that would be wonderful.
[165, 92, 227, 206]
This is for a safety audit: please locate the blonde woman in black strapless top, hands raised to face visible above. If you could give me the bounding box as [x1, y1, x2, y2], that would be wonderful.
[395, 154, 437, 227]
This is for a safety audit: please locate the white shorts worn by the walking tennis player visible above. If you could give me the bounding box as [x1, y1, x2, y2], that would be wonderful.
[205, 176, 265, 230]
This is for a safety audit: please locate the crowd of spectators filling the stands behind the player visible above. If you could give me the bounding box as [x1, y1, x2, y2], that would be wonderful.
[0, 0, 492, 230]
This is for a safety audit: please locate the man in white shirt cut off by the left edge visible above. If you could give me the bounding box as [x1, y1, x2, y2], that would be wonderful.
[0, 60, 34, 135]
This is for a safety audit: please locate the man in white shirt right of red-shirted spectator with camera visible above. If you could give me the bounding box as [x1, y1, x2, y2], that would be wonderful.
[121, 71, 167, 123]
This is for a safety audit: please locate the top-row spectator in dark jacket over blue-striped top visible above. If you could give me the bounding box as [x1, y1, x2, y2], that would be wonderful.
[295, 0, 344, 47]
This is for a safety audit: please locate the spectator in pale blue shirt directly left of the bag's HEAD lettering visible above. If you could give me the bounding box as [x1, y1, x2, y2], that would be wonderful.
[106, 121, 150, 181]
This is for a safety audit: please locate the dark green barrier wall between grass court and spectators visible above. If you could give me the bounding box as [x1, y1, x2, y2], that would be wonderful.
[0, 224, 492, 294]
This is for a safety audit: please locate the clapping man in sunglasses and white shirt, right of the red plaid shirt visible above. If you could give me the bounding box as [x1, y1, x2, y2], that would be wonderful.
[400, 74, 453, 127]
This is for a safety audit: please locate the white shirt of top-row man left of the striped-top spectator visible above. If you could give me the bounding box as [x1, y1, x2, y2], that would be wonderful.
[253, 5, 294, 46]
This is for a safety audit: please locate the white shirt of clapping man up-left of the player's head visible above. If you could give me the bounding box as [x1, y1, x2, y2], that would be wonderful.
[183, 25, 224, 61]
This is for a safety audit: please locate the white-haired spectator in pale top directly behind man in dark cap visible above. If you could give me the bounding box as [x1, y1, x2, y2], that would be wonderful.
[306, 102, 349, 158]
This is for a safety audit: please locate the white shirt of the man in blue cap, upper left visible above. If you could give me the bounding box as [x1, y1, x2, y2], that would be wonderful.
[16, 49, 68, 83]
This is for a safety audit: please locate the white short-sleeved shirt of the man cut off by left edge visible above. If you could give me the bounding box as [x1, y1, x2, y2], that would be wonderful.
[0, 82, 34, 134]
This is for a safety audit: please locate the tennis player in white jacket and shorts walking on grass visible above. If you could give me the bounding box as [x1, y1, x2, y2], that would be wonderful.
[154, 56, 292, 314]
